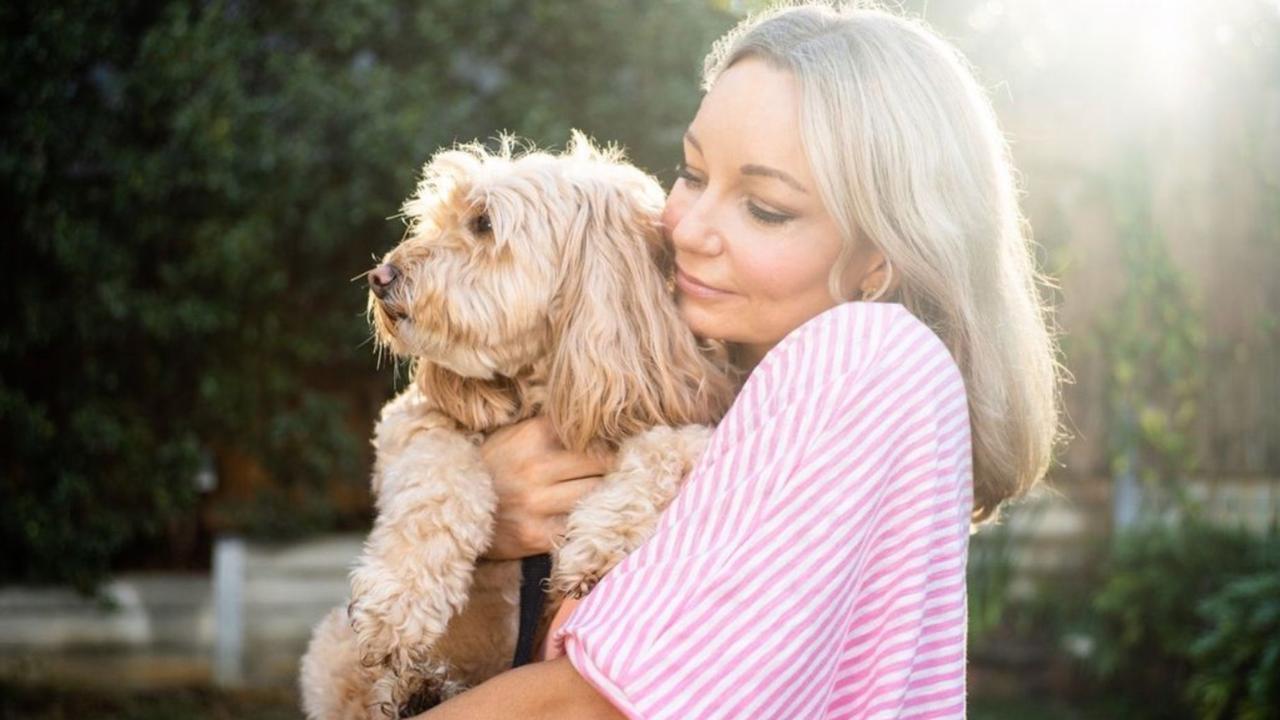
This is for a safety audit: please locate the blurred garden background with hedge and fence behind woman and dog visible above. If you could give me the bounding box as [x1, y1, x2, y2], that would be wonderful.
[0, 0, 1280, 719]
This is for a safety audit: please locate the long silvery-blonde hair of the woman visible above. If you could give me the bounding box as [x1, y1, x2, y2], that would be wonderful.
[703, 4, 1061, 523]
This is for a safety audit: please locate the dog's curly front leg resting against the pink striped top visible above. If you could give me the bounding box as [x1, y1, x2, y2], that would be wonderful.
[550, 425, 710, 597]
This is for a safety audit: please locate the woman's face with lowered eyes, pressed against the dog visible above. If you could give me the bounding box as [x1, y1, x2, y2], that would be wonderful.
[662, 58, 865, 364]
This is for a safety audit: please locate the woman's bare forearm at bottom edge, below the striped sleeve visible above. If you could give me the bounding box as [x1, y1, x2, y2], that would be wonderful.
[417, 656, 625, 720]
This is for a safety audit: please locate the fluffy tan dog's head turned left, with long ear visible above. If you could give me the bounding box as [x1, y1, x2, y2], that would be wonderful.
[369, 132, 731, 447]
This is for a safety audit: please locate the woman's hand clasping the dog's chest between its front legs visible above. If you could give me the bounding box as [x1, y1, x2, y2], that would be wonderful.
[480, 416, 613, 560]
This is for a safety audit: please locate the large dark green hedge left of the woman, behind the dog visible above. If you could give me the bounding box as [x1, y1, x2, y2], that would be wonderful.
[0, 0, 732, 587]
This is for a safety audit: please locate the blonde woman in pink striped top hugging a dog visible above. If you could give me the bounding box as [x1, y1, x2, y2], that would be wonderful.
[414, 6, 1057, 719]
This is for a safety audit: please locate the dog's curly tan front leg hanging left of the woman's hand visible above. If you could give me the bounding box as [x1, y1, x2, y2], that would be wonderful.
[351, 422, 497, 706]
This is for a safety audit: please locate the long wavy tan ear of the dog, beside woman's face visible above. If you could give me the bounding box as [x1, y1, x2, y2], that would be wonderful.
[548, 144, 732, 450]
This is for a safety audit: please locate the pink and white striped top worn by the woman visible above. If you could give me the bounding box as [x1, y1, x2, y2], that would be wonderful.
[554, 302, 973, 720]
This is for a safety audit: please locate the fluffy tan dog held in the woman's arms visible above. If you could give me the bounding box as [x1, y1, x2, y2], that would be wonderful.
[301, 133, 732, 720]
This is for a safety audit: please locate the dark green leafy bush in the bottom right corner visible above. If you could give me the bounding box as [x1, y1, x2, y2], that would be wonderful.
[1032, 523, 1280, 719]
